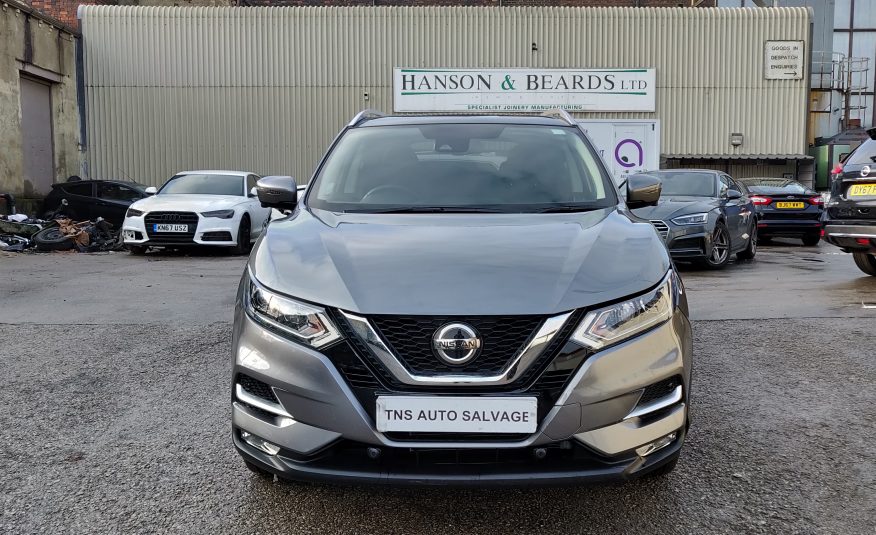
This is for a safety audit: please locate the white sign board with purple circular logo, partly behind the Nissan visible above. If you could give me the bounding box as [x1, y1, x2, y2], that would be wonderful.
[578, 119, 660, 184]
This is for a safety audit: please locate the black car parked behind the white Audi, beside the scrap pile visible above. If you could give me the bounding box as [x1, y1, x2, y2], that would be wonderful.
[43, 180, 149, 228]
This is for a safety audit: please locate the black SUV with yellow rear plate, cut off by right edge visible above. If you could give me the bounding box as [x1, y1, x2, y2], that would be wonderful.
[824, 128, 876, 276]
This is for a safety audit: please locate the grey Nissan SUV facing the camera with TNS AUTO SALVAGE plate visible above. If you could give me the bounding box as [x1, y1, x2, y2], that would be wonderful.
[232, 112, 692, 486]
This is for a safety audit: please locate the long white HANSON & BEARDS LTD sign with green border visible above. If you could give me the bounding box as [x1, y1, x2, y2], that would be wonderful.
[393, 69, 656, 112]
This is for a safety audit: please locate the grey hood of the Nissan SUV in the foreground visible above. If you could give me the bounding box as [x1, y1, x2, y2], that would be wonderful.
[250, 208, 670, 315]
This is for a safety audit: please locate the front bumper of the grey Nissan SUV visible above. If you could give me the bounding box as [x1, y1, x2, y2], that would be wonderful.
[232, 309, 692, 485]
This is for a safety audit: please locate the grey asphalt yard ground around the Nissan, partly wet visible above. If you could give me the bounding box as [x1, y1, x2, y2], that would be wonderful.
[0, 241, 876, 535]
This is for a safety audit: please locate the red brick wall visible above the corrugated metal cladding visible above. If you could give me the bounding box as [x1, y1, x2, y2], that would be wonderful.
[27, 0, 717, 28]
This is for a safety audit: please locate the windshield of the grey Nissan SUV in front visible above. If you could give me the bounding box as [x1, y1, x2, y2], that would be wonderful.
[307, 123, 617, 213]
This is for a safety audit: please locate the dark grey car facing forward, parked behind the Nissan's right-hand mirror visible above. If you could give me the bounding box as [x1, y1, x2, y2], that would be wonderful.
[633, 169, 758, 269]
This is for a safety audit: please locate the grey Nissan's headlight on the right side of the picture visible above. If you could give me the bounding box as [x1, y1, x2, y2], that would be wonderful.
[572, 270, 681, 349]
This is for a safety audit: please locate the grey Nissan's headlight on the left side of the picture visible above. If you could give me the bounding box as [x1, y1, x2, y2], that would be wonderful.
[244, 274, 341, 347]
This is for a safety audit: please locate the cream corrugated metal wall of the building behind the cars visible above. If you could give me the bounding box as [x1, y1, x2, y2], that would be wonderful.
[81, 6, 809, 184]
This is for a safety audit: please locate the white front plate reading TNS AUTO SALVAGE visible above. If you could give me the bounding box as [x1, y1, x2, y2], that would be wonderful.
[377, 396, 538, 433]
